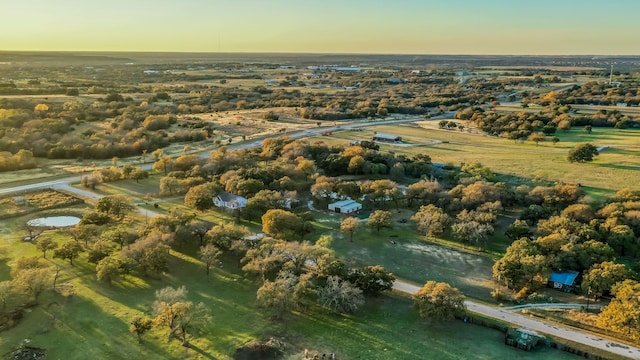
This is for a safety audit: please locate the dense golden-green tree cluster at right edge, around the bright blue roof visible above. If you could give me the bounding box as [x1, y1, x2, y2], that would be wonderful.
[493, 185, 640, 295]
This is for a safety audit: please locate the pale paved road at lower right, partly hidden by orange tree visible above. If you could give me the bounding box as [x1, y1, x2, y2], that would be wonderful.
[393, 281, 640, 359]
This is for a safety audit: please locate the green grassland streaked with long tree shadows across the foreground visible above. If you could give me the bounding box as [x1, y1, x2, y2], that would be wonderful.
[0, 212, 571, 360]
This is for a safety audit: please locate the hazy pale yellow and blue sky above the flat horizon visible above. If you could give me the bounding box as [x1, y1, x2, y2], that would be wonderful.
[0, 0, 640, 55]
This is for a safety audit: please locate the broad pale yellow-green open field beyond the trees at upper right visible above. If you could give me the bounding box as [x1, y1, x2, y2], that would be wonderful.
[318, 121, 640, 198]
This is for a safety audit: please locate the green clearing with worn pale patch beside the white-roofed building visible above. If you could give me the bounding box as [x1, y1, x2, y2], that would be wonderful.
[314, 211, 494, 301]
